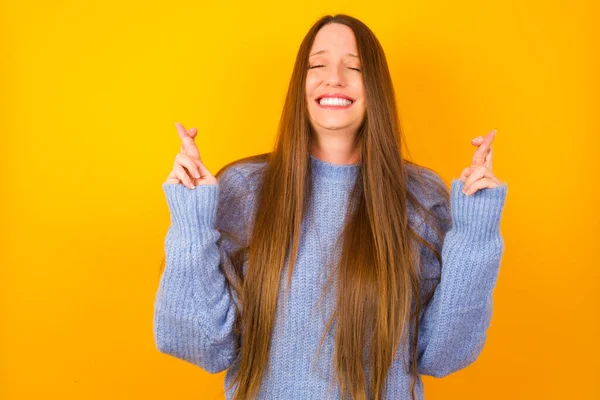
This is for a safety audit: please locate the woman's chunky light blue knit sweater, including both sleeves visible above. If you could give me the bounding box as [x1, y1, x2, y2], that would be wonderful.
[153, 156, 507, 400]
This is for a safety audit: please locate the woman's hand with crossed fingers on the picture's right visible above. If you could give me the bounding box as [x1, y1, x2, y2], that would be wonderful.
[459, 130, 502, 196]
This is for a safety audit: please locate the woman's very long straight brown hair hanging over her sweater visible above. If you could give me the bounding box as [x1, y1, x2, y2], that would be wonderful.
[157, 14, 448, 400]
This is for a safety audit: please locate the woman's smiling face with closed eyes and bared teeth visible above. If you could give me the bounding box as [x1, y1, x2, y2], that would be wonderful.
[306, 23, 366, 139]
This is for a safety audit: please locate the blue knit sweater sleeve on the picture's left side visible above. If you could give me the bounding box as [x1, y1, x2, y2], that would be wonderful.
[153, 170, 248, 373]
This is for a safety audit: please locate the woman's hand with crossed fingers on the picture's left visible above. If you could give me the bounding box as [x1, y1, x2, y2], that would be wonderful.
[165, 122, 218, 189]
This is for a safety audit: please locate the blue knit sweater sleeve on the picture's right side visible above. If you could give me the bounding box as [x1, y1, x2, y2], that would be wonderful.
[418, 179, 507, 378]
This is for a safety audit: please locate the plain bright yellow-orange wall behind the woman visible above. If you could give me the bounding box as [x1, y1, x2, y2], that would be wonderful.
[0, 0, 600, 400]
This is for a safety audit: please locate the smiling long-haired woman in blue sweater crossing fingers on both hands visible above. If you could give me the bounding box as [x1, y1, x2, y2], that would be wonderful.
[154, 15, 507, 400]
